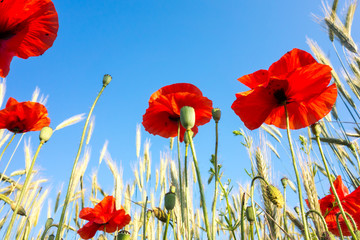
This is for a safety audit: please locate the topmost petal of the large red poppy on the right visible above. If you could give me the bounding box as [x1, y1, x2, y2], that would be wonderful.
[269, 48, 316, 77]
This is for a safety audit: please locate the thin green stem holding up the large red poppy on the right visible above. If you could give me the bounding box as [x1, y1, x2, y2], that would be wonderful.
[284, 103, 310, 240]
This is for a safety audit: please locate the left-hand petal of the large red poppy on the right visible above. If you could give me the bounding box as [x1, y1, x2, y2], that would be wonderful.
[231, 87, 278, 130]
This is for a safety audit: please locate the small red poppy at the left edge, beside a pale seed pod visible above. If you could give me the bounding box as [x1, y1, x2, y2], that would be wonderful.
[0, 98, 50, 133]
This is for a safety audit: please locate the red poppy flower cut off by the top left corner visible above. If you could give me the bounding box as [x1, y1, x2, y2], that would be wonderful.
[0, 0, 59, 77]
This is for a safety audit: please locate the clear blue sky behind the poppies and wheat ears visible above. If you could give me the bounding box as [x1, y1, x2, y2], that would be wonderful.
[5, 0, 359, 223]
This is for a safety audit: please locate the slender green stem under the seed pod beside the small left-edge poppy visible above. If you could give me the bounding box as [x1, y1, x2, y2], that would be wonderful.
[4, 141, 45, 240]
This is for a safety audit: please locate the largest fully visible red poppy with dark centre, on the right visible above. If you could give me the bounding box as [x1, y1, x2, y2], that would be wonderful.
[231, 48, 337, 130]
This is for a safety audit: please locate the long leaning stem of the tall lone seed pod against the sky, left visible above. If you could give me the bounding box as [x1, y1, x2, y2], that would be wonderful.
[55, 85, 106, 240]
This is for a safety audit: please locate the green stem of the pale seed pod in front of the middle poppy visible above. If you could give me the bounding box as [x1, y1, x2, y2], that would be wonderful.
[186, 129, 212, 240]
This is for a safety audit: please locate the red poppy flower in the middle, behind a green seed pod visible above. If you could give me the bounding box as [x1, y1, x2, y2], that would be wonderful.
[143, 83, 212, 141]
